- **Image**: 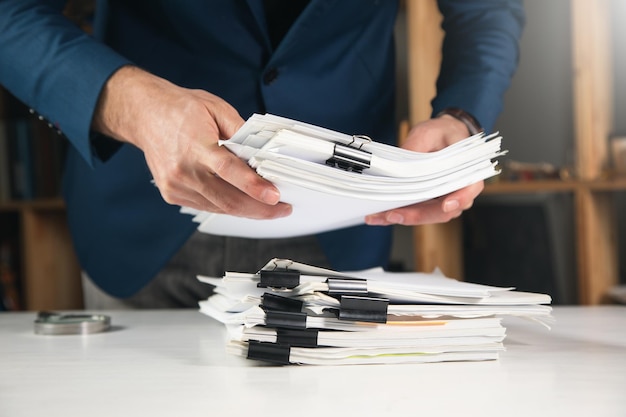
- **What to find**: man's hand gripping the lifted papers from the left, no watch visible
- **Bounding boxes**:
[92,66,291,219]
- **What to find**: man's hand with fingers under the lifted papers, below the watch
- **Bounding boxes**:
[365,115,484,226]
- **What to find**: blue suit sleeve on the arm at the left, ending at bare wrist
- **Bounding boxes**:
[0,0,129,165]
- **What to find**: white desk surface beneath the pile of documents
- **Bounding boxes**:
[0,306,626,417]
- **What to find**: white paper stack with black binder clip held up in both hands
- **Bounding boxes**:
[181,114,503,238]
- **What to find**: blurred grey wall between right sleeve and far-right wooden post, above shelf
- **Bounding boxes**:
[496,0,573,166]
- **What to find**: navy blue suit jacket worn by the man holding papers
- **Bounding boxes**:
[0,0,524,297]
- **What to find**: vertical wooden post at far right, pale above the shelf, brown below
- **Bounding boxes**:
[571,0,618,304]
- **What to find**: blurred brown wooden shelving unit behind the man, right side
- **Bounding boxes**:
[406,0,626,304]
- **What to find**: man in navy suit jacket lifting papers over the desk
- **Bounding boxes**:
[0,0,524,307]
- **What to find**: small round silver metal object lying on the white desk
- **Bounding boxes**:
[35,311,111,335]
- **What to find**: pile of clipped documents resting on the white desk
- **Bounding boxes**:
[198,259,552,365]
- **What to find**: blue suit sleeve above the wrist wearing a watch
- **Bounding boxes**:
[432,0,525,132]
